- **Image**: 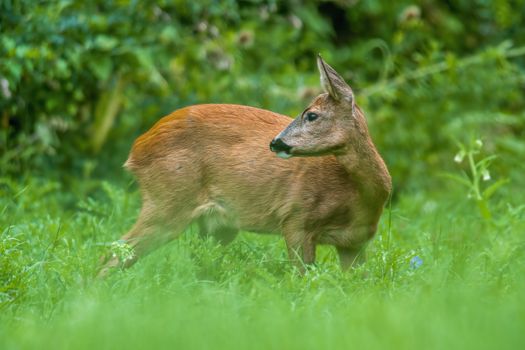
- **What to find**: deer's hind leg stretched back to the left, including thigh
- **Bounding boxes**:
[97,149,205,275]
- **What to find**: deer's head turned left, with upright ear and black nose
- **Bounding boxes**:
[270,56,368,158]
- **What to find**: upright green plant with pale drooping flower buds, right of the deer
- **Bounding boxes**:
[445,139,509,220]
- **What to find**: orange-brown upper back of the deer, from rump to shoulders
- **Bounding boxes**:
[126,104,291,170]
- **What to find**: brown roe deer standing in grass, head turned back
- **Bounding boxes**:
[99,55,392,276]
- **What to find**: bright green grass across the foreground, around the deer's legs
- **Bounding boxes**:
[0,179,525,349]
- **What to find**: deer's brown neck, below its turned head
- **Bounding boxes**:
[336,137,392,210]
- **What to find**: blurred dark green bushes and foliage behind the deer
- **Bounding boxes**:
[0,0,525,192]
